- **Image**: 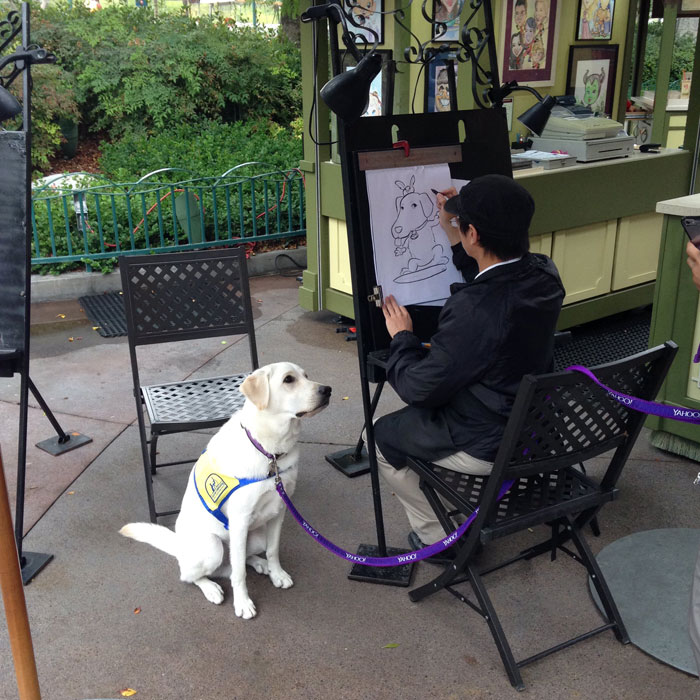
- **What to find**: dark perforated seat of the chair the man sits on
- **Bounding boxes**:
[422,459,617,542]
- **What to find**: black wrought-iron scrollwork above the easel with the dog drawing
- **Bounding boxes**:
[344,0,499,108]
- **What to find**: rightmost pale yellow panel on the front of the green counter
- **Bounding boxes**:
[612,212,664,291]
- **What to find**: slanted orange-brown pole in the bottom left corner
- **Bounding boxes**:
[0,454,41,700]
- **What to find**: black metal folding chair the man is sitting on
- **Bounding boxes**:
[409,341,678,690]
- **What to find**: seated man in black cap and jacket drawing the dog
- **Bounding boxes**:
[375,175,564,549]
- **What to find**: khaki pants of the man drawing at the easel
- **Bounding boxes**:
[377,448,493,544]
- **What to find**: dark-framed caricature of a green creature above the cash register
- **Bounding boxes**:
[566,44,619,115]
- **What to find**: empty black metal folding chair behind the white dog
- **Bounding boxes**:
[119,248,258,522]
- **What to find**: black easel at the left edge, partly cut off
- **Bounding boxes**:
[0,3,92,584]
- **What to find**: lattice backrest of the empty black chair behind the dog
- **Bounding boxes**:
[119,247,258,358]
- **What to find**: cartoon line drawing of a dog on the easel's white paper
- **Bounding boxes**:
[391,175,449,274]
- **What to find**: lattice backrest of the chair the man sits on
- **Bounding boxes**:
[483,341,678,520]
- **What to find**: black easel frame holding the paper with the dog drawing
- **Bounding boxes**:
[339,110,512,586]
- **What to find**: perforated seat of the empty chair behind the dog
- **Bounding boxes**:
[141,372,250,432]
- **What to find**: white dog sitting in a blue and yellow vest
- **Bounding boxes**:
[120,362,331,619]
